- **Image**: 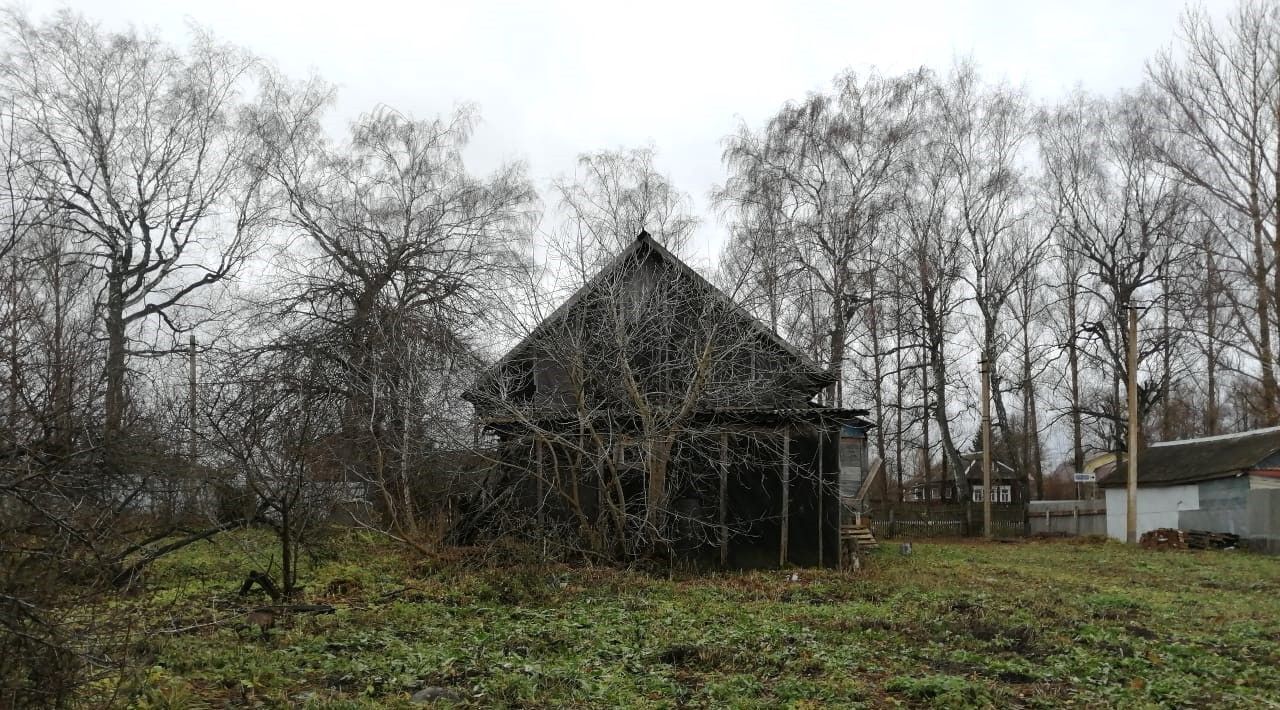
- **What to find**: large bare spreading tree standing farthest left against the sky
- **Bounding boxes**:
[0,12,270,438]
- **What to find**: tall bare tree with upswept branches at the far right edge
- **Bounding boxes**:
[1148,0,1280,425]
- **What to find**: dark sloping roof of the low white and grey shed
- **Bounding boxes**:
[1098,426,1280,486]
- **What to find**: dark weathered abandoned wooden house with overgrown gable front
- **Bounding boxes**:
[465,232,872,568]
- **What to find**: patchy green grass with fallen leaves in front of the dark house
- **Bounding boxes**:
[112,532,1280,709]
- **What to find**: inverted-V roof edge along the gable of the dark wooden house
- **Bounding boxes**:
[463,230,836,398]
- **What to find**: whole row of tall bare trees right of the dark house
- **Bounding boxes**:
[716,1,1280,495]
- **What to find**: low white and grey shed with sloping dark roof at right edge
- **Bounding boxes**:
[1098,427,1280,553]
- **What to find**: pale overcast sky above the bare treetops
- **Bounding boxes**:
[24,0,1234,264]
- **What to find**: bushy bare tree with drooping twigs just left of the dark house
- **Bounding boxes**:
[252,101,534,545]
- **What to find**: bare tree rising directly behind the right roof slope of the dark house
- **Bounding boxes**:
[718,72,924,403]
